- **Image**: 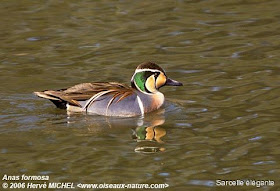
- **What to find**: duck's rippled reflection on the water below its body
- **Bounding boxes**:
[67,109,166,153]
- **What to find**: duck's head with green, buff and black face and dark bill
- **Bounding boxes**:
[131,62,183,94]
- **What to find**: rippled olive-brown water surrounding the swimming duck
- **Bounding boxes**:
[0,0,280,191]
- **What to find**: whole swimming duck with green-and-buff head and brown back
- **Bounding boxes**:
[34,62,183,117]
